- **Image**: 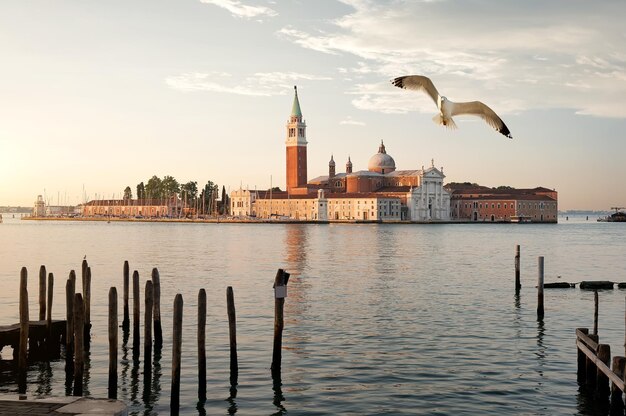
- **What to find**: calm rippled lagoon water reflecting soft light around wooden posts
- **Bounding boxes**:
[0,215,626,415]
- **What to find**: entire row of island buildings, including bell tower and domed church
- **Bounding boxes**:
[44,87,558,222]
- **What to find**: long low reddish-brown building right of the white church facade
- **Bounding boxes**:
[448,184,558,223]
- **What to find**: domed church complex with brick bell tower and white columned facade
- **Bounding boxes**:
[231,87,451,221]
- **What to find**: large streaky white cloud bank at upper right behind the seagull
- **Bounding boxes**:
[278,0,626,117]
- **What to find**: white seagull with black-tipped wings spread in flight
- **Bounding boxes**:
[391,75,513,139]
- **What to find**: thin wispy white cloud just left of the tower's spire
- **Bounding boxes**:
[165,72,332,97]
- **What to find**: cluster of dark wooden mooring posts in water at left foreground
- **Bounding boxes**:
[11,260,289,414]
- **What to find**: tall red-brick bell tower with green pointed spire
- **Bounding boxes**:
[285,86,307,193]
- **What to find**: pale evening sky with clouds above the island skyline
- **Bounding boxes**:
[0,0,626,210]
